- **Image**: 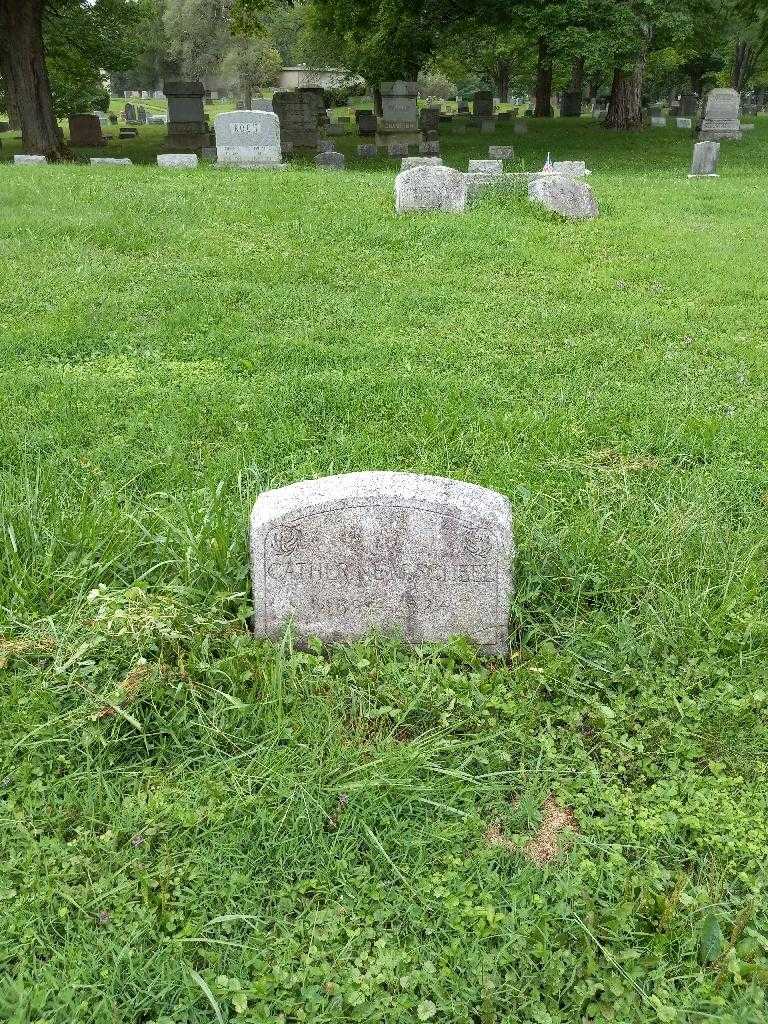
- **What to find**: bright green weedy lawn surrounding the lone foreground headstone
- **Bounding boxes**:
[0,124,768,1024]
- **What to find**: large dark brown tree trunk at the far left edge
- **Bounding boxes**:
[0,0,63,160]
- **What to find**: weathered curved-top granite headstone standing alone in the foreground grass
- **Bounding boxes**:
[251,472,514,654]
